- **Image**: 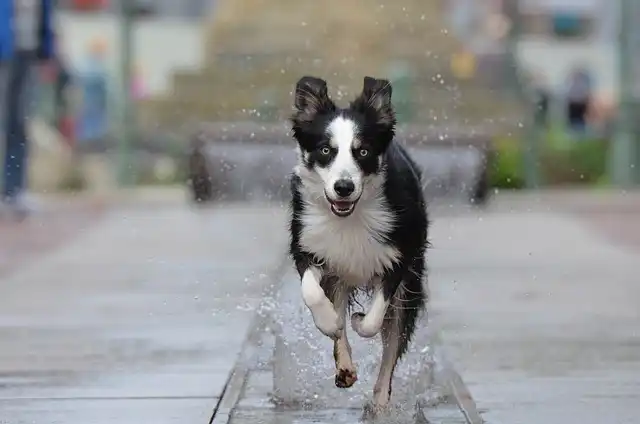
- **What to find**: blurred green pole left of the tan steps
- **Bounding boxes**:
[117,0,135,186]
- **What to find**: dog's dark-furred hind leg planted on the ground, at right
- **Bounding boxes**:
[373,278,425,413]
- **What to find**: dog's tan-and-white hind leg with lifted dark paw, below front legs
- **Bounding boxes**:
[330,283,358,388]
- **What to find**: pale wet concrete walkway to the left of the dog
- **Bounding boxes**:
[0,201,286,424]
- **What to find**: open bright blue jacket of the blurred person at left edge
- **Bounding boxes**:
[0,0,54,62]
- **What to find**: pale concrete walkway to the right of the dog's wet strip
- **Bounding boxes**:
[430,199,640,424]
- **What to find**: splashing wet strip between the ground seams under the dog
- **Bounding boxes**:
[222,264,480,424]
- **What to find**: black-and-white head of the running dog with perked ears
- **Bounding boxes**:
[291,76,396,217]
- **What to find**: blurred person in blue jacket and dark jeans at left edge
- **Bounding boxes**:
[0,0,54,217]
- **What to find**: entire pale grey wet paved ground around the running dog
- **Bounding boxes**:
[0,192,640,424]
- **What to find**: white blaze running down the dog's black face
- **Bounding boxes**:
[318,116,362,199]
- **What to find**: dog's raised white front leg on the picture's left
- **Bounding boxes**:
[302,266,344,340]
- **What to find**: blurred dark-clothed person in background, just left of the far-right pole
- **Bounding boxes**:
[566,67,593,134]
